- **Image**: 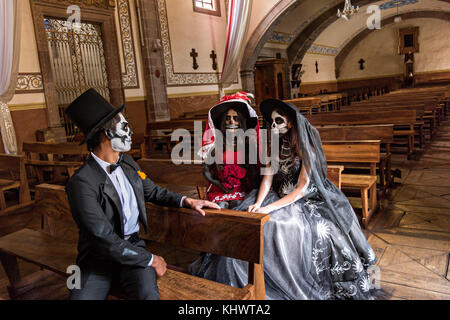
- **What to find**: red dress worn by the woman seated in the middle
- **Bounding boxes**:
[206,151,250,203]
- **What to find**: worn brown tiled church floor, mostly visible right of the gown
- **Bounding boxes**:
[0,121,450,299]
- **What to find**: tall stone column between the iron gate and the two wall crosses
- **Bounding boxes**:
[136,0,170,121]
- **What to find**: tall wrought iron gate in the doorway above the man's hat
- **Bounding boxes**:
[44,18,109,139]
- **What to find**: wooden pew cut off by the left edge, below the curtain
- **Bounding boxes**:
[0,154,33,215]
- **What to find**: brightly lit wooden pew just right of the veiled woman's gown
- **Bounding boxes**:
[323,140,381,228]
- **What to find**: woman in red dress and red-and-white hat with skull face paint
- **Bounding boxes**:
[199,92,259,209]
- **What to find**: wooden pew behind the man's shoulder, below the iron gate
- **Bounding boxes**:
[22,141,89,183]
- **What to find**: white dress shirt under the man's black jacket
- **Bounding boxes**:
[91,152,153,266]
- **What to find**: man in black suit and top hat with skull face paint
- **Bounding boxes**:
[66,89,219,300]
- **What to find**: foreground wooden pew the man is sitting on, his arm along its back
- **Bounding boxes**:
[0,184,269,300]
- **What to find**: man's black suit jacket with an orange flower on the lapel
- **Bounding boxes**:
[66,154,182,268]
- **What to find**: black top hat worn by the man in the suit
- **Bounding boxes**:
[65,89,125,144]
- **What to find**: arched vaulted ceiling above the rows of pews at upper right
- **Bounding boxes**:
[265,0,450,63]
